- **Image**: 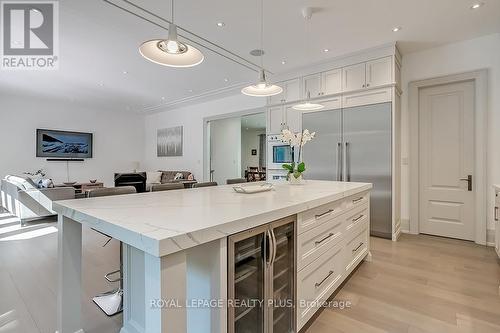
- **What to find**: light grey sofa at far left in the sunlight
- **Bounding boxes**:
[1,175,75,225]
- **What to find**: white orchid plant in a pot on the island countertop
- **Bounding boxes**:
[281,129,316,181]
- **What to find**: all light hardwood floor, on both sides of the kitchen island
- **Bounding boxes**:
[0,209,500,333]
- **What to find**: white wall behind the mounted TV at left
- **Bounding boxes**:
[0,95,144,186]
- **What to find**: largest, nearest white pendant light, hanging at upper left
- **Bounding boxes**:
[139,0,205,67]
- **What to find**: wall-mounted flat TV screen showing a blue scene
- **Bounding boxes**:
[36,129,92,158]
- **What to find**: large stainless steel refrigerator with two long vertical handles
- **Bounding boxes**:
[302,103,392,238]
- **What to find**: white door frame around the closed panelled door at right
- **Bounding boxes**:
[408,69,488,245]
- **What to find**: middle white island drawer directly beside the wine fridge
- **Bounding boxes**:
[297,216,344,270]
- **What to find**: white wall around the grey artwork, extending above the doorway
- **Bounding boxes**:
[144,94,266,180]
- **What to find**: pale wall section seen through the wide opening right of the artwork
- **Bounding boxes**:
[210,117,241,184]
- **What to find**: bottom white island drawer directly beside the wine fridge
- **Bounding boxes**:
[297,243,344,330]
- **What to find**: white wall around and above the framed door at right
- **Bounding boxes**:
[401,34,500,229]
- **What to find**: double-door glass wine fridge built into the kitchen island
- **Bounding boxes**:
[228,217,296,333]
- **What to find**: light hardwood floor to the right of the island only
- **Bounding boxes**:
[307,235,500,333]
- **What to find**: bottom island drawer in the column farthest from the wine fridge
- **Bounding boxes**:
[344,220,368,274]
